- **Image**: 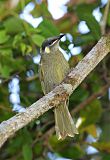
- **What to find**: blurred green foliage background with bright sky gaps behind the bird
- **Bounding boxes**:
[0,0,110,160]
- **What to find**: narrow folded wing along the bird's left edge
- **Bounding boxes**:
[39,62,46,94]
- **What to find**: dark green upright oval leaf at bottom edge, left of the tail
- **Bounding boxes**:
[22,144,33,160]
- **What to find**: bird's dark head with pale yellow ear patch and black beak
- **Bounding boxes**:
[41,34,65,53]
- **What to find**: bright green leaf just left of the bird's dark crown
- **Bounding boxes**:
[32,34,45,47]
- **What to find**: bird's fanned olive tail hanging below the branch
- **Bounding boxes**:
[54,103,78,139]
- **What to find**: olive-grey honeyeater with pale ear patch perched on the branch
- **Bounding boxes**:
[39,34,78,139]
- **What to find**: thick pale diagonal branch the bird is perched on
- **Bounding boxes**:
[0,37,110,147]
